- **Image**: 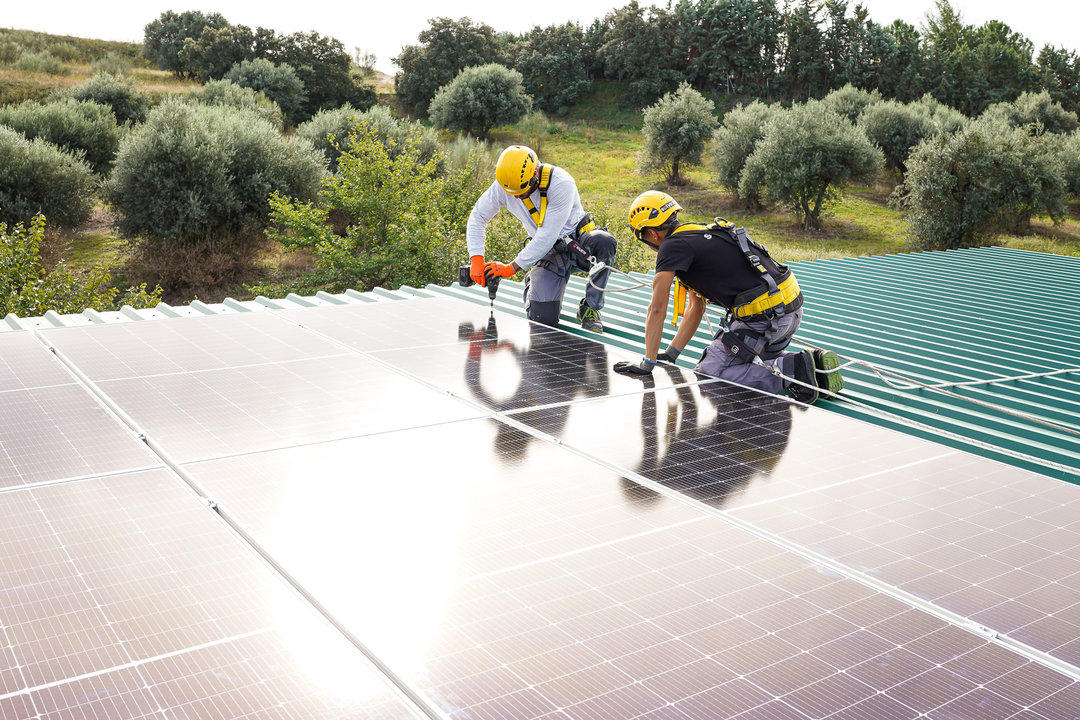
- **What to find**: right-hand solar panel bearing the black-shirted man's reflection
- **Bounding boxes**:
[514,375,1080,665]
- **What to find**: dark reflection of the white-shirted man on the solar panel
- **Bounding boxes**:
[458,315,610,463]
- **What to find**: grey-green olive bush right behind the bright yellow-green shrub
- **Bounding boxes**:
[296,105,443,173]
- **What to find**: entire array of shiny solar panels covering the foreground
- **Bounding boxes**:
[0,300,1080,720]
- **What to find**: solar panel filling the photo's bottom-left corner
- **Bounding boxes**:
[0,470,422,720]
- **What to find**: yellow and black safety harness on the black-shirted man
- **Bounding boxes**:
[672,218,802,363]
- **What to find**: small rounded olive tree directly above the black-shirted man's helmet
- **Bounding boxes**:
[642,82,717,185]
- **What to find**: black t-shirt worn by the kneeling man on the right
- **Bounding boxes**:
[657,222,775,310]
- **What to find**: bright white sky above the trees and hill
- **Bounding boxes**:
[8,0,1080,74]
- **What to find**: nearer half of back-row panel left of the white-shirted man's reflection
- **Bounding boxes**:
[92,354,477,461]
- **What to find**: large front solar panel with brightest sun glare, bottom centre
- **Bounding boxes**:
[185,416,1071,719]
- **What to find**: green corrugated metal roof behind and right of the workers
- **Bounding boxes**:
[429,247,1080,483]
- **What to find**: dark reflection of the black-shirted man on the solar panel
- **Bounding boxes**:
[622,366,794,507]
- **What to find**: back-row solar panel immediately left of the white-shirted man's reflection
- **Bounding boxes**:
[46,314,477,461]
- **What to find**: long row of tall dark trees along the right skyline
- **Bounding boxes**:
[394,0,1080,117]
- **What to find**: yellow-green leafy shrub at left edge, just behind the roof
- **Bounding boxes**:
[0,215,161,316]
